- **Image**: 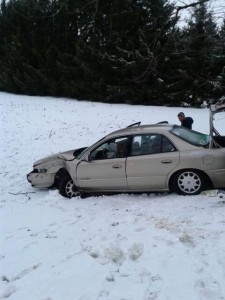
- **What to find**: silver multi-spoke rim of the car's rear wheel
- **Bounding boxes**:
[178,172,202,194]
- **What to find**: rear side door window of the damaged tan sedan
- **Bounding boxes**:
[130,134,176,156]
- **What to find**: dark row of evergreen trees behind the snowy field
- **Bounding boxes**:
[0,0,225,107]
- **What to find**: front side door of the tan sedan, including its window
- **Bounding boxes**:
[76,137,128,191]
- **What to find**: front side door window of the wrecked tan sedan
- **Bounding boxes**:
[90,137,128,160]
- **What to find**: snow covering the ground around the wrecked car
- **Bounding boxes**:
[0,93,225,300]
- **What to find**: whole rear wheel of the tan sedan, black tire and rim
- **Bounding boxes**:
[171,170,205,196]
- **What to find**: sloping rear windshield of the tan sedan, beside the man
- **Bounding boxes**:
[170,125,209,147]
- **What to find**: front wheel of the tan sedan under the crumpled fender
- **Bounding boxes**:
[59,174,80,198]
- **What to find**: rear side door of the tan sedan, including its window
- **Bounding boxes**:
[126,134,179,191]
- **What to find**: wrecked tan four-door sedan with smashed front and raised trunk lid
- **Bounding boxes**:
[27,105,225,198]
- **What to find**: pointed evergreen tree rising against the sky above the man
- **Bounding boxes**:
[181,4,219,106]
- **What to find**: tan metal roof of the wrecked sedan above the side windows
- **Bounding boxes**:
[107,124,174,137]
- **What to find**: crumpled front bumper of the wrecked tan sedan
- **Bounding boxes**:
[27,170,55,188]
